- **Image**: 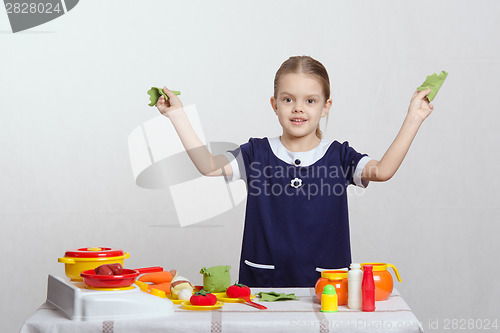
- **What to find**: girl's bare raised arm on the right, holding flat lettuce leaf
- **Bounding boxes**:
[361,89,434,182]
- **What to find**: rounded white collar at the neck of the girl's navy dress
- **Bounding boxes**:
[267,136,332,166]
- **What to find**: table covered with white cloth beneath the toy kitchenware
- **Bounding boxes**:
[20,288,423,333]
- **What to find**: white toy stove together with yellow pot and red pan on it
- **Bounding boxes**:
[47,247,174,321]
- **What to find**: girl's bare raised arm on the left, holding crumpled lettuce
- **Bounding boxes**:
[156,87,233,176]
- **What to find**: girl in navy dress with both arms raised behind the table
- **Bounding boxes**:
[157,56,433,287]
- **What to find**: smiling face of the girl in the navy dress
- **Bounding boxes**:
[271,73,332,139]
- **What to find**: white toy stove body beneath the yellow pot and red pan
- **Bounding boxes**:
[47,274,174,321]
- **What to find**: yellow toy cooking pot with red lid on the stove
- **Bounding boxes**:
[58,247,130,281]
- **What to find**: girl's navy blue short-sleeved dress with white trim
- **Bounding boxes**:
[227,138,366,287]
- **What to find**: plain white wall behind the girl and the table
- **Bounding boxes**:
[0,0,500,332]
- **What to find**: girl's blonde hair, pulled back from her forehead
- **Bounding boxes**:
[274,56,330,139]
